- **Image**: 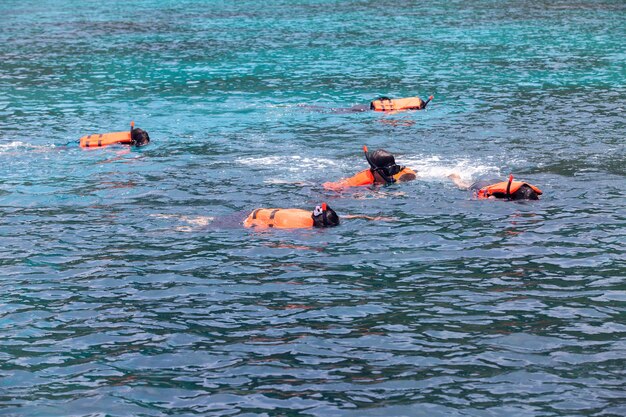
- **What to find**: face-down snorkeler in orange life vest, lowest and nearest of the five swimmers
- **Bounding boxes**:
[243,203,339,229]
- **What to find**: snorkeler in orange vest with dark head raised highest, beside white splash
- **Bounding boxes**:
[322,146,417,191]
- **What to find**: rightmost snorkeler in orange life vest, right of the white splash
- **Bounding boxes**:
[448,174,543,200]
